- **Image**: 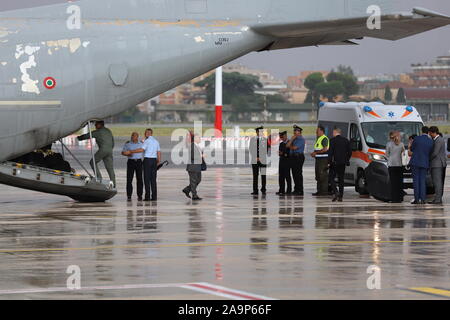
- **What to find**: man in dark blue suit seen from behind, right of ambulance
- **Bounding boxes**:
[409,127,433,204]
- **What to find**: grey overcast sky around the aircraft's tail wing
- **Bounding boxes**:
[238,0,450,79]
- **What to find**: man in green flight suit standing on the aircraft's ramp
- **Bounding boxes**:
[78,121,116,187]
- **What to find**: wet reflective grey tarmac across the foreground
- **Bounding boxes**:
[0,166,450,300]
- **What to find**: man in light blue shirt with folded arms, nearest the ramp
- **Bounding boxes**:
[122,132,144,201]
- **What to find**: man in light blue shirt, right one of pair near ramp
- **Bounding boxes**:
[127,129,161,201]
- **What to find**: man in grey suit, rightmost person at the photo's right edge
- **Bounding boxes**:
[429,127,447,204]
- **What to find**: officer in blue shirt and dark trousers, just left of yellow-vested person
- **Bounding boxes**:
[286,125,306,196]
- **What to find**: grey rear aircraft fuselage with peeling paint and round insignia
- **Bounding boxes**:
[0,0,271,161]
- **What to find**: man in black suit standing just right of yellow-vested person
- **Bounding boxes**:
[328,128,352,202]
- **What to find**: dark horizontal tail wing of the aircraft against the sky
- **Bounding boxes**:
[253,8,450,50]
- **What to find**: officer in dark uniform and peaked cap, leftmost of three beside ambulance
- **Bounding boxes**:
[250,126,269,195]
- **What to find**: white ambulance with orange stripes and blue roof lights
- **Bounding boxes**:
[319,102,423,194]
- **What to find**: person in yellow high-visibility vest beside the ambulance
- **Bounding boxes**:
[311,126,330,196]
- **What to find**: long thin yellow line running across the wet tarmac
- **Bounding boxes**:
[0,240,450,253]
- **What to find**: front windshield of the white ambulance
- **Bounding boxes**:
[362,122,423,149]
